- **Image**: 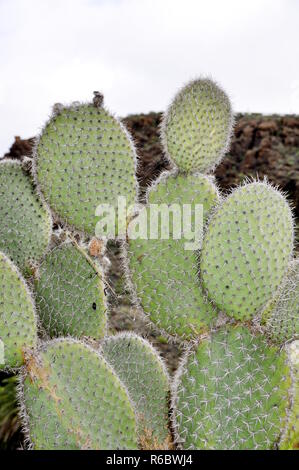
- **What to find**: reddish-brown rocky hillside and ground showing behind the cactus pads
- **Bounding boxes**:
[0,113,299,449]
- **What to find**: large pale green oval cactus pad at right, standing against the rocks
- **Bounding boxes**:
[200,182,293,320]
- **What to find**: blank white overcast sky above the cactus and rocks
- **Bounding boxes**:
[0,0,299,156]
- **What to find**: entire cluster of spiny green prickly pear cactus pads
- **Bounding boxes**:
[0,79,299,450]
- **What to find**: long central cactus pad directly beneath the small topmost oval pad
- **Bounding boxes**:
[128,174,218,338]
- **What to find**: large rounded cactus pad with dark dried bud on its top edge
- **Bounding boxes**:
[35,104,136,236]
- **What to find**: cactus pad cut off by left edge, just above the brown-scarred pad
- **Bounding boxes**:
[0,252,37,369]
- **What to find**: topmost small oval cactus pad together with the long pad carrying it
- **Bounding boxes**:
[127,80,233,339]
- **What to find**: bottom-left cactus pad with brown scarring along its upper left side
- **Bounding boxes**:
[21,339,137,450]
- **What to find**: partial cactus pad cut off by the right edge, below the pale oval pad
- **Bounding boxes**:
[266,259,299,343]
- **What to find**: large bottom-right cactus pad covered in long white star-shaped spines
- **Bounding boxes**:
[173,326,291,450]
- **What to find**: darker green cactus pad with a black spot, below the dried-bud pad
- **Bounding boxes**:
[35,242,107,339]
